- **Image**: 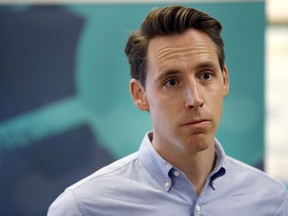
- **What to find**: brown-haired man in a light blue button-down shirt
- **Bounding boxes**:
[48,6,288,216]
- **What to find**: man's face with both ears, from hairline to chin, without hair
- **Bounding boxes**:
[131,29,229,155]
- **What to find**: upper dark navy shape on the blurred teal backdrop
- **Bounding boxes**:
[0,6,85,121]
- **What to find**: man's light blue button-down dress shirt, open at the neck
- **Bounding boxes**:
[48,133,288,216]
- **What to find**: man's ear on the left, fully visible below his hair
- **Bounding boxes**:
[130,79,149,111]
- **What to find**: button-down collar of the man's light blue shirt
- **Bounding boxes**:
[139,131,226,191]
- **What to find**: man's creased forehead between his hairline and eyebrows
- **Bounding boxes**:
[147,29,218,69]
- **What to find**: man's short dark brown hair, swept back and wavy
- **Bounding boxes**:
[125,6,225,88]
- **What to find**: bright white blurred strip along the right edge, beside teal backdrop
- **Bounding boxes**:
[264,0,288,189]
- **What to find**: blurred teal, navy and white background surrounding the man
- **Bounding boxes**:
[0,0,288,216]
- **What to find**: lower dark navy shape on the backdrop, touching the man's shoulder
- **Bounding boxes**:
[0,125,114,216]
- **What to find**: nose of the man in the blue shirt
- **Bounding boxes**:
[185,83,204,109]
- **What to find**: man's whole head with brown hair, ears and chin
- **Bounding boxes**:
[126,4,229,157]
